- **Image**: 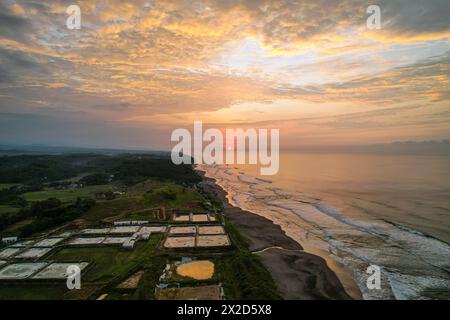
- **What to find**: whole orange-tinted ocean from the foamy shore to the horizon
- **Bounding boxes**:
[198,152,450,299]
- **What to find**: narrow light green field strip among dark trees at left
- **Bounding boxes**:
[23,184,114,202]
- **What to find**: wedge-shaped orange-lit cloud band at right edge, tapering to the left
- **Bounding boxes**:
[274,52,450,104]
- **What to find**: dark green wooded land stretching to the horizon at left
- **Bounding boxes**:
[0,154,201,236]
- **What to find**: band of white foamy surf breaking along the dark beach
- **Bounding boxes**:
[198,165,450,299]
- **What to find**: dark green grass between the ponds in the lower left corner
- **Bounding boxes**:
[0,234,165,300]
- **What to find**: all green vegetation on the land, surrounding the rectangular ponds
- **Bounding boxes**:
[0,154,280,299]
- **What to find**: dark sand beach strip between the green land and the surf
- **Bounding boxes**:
[197,170,361,300]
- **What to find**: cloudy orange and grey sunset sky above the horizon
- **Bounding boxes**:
[0,0,450,149]
